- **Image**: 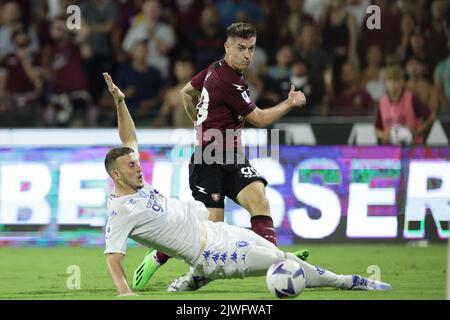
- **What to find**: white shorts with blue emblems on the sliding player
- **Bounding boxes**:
[193,221,279,279]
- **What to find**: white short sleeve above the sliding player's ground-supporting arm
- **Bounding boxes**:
[104,216,131,255]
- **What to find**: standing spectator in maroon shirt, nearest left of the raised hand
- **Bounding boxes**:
[42,18,96,127]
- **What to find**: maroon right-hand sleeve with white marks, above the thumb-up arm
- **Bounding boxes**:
[221,83,256,117]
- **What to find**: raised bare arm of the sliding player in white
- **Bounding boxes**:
[103,72,139,152]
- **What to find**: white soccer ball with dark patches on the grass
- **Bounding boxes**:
[266,260,306,299]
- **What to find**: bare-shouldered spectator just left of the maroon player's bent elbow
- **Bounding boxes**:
[153,58,195,128]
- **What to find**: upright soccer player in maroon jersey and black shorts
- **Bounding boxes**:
[133,22,308,289]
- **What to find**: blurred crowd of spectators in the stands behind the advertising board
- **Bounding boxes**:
[0,0,450,128]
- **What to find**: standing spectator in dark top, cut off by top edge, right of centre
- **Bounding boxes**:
[321,0,359,91]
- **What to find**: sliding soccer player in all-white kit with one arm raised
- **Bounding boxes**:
[103,73,391,296]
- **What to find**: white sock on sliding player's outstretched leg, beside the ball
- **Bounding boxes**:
[286,252,353,289]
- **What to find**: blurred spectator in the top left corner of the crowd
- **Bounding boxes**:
[0,0,39,60]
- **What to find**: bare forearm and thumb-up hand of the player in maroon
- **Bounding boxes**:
[245,85,306,128]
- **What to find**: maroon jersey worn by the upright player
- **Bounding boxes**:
[191,60,256,149]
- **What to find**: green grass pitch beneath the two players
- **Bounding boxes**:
[0,244,448,300]
